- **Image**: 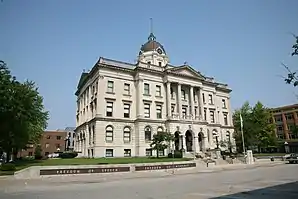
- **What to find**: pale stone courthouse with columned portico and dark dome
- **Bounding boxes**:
[75,33,234,157]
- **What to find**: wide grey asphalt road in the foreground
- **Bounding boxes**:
[0,164,298,199]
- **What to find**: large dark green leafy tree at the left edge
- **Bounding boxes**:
[0,61,48,160]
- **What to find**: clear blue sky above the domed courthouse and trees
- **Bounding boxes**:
[0,0,298,129]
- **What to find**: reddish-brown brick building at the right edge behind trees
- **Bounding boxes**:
[271,104,298,152]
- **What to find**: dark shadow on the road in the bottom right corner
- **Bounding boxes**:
[211,181,298,199]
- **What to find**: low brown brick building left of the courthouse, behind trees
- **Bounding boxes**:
[19,130,67,157]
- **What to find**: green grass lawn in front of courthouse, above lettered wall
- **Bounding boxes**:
[0,157,191,176]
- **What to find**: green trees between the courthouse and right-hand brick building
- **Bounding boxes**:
[233,102,277,151]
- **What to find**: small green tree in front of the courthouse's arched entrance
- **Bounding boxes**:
[150,132,175,158]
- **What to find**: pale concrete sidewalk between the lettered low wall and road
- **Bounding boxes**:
[0,161,285,188]
